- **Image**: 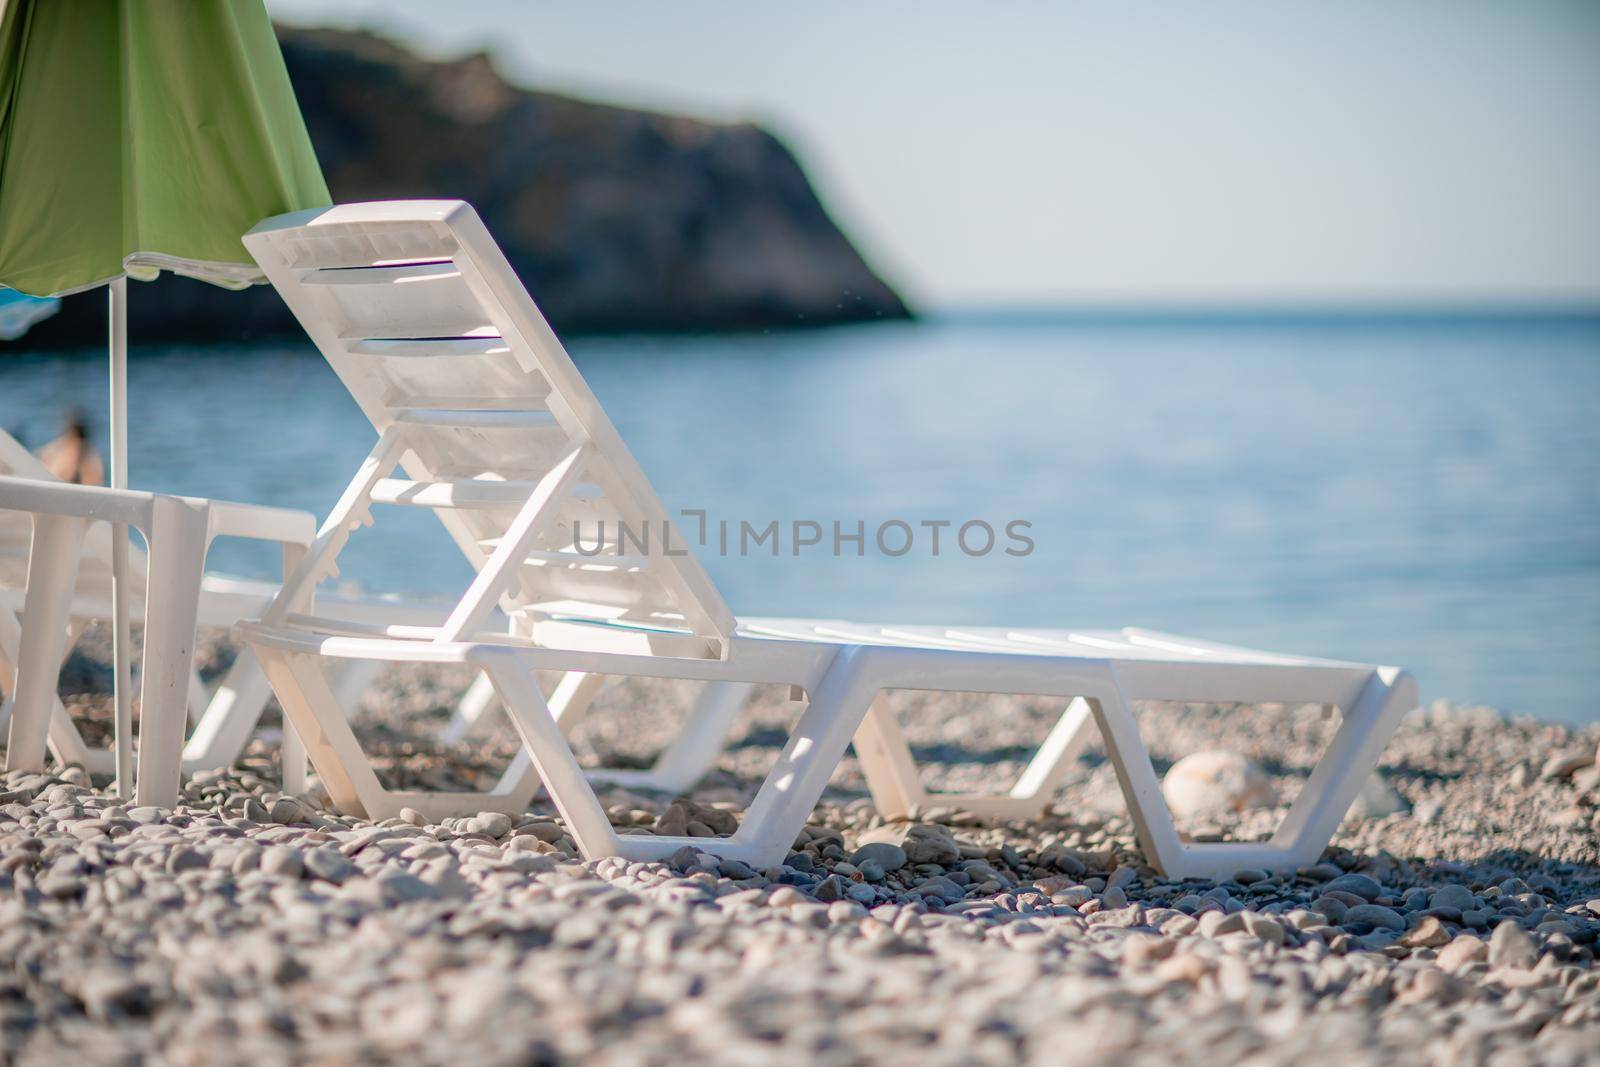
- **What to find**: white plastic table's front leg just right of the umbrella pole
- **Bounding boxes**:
[134,496,206,808]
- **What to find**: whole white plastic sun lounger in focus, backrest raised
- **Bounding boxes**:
[240,200,1416,877]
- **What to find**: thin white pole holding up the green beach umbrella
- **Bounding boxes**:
[106,278,133,800]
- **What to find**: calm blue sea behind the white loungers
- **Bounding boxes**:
[0,318,1600,720]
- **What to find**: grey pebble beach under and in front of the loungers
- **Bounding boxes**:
[0,645,1600,1067]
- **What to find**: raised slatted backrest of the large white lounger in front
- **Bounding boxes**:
[245,200,734,656]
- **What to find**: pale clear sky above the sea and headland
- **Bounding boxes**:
[267,0,1600,309]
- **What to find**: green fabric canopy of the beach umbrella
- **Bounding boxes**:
[0,0,330,296]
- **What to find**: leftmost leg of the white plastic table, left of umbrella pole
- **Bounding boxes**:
[6,515,86,771]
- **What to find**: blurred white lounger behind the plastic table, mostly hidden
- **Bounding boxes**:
[0,430,448,787]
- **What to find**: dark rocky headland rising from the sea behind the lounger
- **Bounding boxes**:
[8,27,907,347]
